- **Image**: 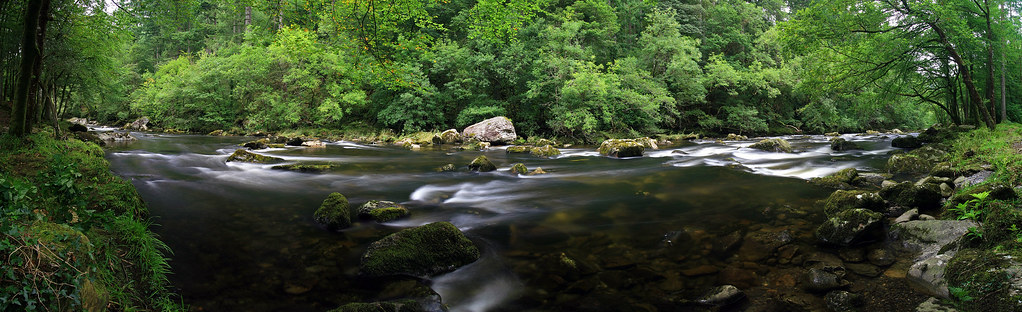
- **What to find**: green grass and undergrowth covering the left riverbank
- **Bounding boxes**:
[0,129,184,311]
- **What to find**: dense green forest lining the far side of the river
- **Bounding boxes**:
[0,0,1022,141]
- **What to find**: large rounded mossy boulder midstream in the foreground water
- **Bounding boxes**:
[360,222,479,277]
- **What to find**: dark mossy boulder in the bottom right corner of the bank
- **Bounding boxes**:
[945,246,1022,311]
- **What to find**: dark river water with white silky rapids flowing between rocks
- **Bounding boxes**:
[107,134,919,311]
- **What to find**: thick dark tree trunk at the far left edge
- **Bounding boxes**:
[8,0,43,137]
